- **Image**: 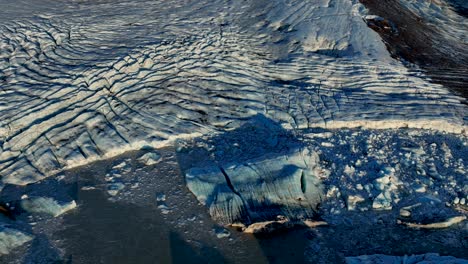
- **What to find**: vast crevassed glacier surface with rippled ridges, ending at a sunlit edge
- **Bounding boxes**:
[0,0,466,184]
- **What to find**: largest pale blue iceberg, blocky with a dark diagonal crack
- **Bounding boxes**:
[186,151,323,223]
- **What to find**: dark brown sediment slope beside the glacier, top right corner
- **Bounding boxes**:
[360,0,468,100]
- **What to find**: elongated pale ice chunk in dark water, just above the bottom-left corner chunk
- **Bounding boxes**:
[21,197,76,217]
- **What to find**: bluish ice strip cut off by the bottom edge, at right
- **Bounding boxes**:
[346,253,468,264]
